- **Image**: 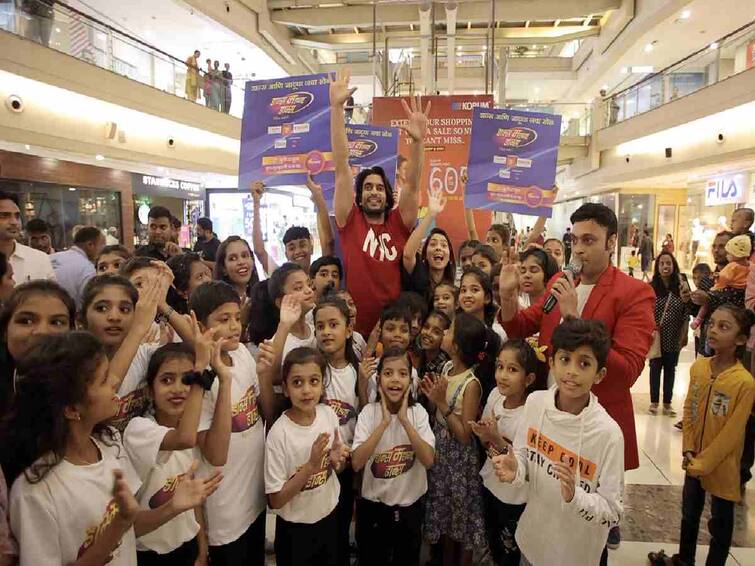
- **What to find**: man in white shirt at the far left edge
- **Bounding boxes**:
[0,191,55,285]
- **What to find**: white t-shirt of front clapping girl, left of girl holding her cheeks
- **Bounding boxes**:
[265,404,341,524]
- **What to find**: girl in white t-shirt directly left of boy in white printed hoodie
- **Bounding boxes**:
[472,340,548,566]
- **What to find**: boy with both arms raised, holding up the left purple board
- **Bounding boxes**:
[251,175,335,275]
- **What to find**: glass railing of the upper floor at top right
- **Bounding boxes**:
[597,21,755,129]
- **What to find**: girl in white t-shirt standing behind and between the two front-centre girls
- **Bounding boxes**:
[314,294,360,564]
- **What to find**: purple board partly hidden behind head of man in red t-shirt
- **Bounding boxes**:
[315,124,399,210]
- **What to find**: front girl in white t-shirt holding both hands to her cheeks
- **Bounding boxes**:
[352,348,435,566]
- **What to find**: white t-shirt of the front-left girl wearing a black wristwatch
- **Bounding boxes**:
[123,416,199,554]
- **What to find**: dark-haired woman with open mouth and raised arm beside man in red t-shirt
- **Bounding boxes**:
[401,190,456,299]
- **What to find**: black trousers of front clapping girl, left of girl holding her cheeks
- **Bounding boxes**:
[276,508,338,566]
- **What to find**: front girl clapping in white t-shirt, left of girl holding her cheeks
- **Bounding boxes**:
[265,348,348,566]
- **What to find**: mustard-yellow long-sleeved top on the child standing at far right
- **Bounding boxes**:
[682,358,755,501]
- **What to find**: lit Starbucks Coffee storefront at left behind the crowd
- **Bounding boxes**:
[131,173,205,247]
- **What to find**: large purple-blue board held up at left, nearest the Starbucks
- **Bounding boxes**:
[239,73,333,191]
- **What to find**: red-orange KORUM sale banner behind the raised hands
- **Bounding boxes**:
[372,94,493,250]
